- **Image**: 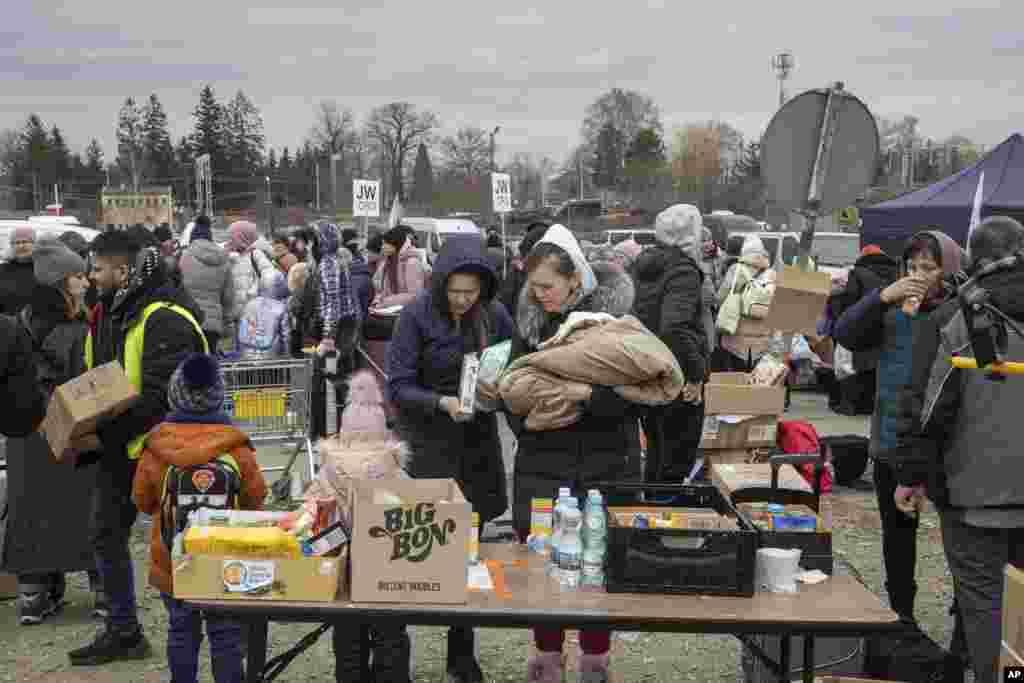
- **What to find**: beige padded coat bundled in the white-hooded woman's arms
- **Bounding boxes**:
[499,313,684,431]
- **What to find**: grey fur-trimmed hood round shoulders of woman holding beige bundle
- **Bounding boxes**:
[516,263,636,347]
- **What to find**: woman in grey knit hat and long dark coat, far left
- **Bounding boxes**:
[0,241,106,626]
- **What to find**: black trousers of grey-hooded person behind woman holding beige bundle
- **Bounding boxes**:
[641,399,705,483]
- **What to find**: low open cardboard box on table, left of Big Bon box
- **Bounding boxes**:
[172,548,348,602]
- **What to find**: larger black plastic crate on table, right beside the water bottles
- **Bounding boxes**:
[594,483,758,597]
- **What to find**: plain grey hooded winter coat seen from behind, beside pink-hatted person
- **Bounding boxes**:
[178,240,238,335]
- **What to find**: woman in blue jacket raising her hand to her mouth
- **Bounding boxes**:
[833,230,963,623]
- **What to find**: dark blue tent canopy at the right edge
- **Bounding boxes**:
[860,133,1024,254]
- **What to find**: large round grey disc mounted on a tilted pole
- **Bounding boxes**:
[761,83,879,215]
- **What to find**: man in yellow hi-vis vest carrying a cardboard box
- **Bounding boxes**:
[69,232,209,666]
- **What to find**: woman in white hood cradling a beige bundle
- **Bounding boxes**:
[509,225,640,683]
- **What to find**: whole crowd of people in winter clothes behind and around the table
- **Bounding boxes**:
[0,205,1024,683]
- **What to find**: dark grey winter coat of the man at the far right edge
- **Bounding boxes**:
[892,265,1024,528]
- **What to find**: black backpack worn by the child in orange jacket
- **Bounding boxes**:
[160,454,242,549]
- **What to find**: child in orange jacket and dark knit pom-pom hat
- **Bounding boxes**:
[132,353,266,683]
